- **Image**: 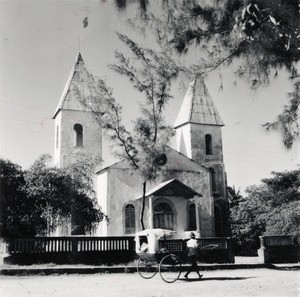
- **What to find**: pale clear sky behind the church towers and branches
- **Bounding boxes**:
[0,0,300,192]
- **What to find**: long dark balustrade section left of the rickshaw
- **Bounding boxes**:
[5,236,134,264]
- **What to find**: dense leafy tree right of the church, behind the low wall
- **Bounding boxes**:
[231,170,300,250]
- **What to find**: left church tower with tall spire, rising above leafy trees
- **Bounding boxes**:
[53,52,102,167]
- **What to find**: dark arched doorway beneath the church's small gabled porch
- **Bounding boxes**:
[154,202,174,230]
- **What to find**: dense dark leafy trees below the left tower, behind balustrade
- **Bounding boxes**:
[0,155,105,237]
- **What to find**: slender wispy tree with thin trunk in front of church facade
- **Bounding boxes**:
[74,34,177,229]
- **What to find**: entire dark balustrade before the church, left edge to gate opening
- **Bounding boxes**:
[4,236,234,265]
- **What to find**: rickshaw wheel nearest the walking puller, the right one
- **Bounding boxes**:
[159,254,181,283]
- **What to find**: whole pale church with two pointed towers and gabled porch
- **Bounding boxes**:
[53,53,230,238]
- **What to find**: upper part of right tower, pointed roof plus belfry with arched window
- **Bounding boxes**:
[174,76,224,165]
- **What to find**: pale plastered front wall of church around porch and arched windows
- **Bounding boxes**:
[98,157,214,237]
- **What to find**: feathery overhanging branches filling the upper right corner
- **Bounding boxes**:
[115,0,300,148]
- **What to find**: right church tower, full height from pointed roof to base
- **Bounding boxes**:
[174,76,230,236]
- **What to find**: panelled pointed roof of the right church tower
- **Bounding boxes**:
[174,76,224,128]
